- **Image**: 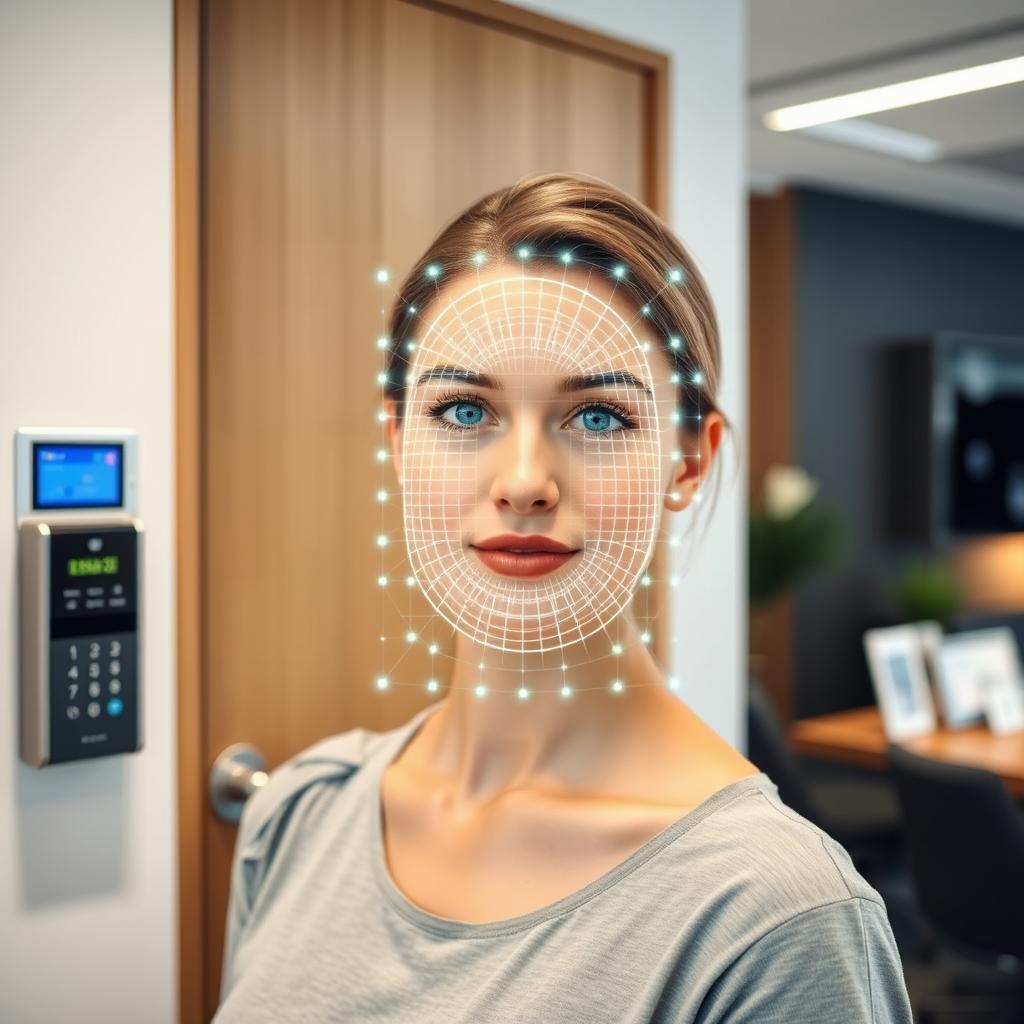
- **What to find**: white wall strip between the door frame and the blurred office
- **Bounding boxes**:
[515,0,746,752]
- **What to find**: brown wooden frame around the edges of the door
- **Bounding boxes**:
[174,0,670,1024]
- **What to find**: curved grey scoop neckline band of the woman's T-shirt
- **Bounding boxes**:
[368,701,774,939]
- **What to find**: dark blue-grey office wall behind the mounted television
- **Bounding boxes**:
[794,189,1024,717]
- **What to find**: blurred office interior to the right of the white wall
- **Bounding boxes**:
[746,0,1024,1021]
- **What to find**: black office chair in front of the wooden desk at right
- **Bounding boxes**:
[889,744,1024,1022]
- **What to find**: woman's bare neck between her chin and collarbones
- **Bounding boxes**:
[403,613,687,807]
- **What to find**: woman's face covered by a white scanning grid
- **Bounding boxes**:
[392,264,682,652]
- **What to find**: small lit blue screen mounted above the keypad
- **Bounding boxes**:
[32,441,124,509]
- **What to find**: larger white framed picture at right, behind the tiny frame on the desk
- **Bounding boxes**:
[938,626,1022,731]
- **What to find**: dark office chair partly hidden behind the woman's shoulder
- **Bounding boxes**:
[746,679,900,876]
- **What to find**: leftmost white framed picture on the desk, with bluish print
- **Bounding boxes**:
[864,626,936,742]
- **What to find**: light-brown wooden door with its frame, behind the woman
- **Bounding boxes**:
[176,0,667,1021]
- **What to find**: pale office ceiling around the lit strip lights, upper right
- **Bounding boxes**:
[748,0,1024,224]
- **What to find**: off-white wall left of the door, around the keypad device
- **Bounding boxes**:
[0,0,177,1024]
